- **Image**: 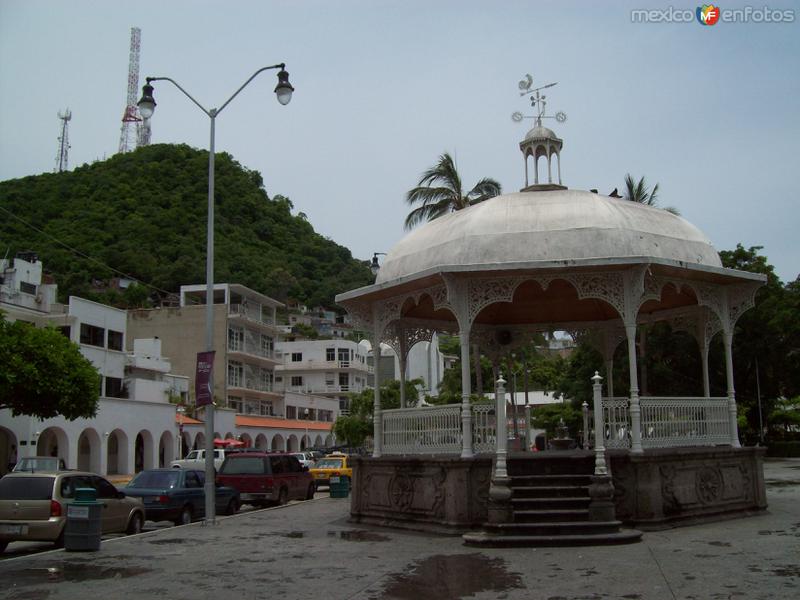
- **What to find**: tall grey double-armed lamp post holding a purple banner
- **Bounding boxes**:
[138,63,294,525]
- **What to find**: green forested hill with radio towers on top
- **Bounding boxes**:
[0,144,373,307]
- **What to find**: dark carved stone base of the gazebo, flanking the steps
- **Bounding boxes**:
[350,447,767,535]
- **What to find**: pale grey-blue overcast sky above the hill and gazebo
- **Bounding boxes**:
[0,0,800,282]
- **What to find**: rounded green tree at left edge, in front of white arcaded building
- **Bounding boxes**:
[0,315,100,421]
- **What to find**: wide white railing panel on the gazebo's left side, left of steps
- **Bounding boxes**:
[381,404,461,454]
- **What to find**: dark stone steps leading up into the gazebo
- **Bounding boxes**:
[463,452,642,547]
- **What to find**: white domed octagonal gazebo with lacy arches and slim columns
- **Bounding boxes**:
[336,123,765,540]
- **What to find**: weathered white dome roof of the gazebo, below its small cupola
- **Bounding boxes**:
[376,189,722,284]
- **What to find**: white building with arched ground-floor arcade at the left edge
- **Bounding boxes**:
[0,253,188,474]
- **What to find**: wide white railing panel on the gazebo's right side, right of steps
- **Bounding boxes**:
[639,397,731,448]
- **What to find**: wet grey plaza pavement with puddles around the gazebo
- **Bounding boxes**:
[0,459,800,600]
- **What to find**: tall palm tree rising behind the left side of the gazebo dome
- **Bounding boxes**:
[405,152,501,229]
